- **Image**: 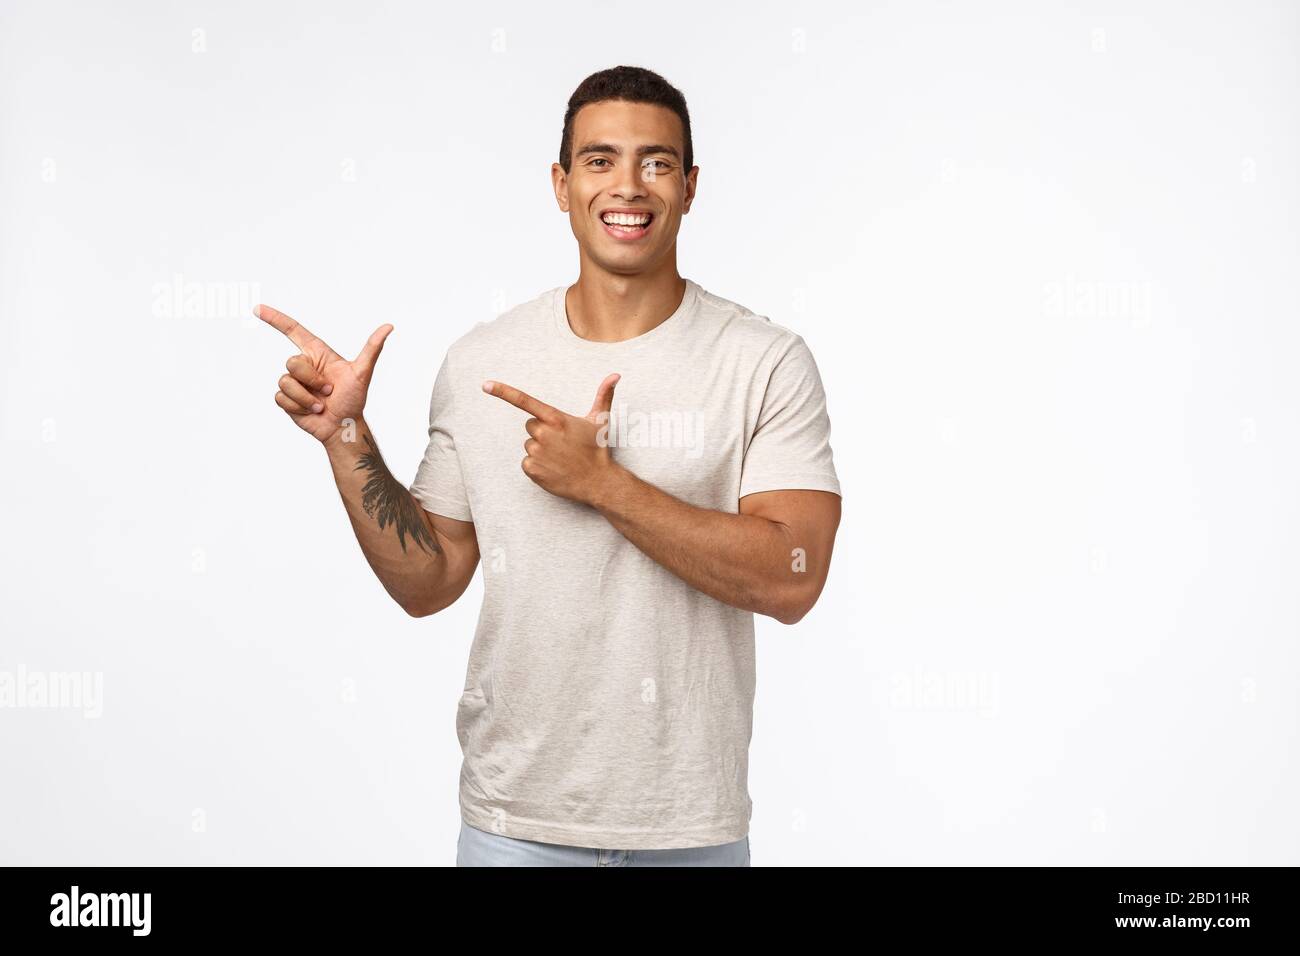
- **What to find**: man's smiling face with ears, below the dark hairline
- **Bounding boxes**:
[551,100,699,276]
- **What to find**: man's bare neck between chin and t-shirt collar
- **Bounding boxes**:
[564,263,686,342]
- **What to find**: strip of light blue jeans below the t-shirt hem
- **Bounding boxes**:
[456,821,749,866]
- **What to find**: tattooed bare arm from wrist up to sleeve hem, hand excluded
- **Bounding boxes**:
[324,420,478,618]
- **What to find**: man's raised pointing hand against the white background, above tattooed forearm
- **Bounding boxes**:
[254,306,393,442]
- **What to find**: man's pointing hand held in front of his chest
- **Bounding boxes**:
[484,373,619,505]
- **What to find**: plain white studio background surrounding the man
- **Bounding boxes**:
[0,0,1300,865]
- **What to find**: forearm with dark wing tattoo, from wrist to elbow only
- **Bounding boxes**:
[325,419,447,613]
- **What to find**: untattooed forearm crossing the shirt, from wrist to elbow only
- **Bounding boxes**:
[592,466,809,623]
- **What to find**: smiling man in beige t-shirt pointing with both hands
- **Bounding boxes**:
[259,66,840,866]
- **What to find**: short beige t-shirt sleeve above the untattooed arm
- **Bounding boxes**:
[740,336,840,498]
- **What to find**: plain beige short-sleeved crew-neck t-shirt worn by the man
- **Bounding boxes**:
[411,280,840,849]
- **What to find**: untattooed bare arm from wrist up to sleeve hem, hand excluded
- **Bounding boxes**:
[590,466,840,624]
